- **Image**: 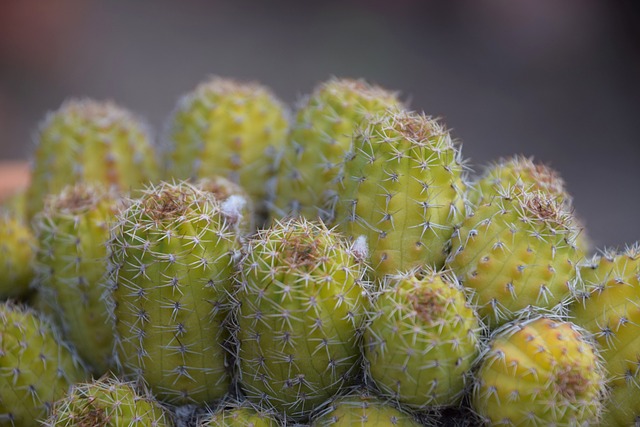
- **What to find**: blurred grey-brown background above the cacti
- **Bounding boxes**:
[0,0,640,247]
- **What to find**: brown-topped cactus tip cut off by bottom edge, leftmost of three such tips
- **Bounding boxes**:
[43,377,171,427]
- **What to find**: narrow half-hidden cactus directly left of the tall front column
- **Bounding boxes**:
[34,184,119,376]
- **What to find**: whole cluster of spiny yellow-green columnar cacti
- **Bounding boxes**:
[0,77,640,427]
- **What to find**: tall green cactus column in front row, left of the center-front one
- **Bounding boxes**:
[109,183,240,404]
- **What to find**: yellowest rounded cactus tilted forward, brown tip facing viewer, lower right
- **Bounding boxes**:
[472,317,604,427]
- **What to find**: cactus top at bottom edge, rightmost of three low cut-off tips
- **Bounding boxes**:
[311,394,421,427]
